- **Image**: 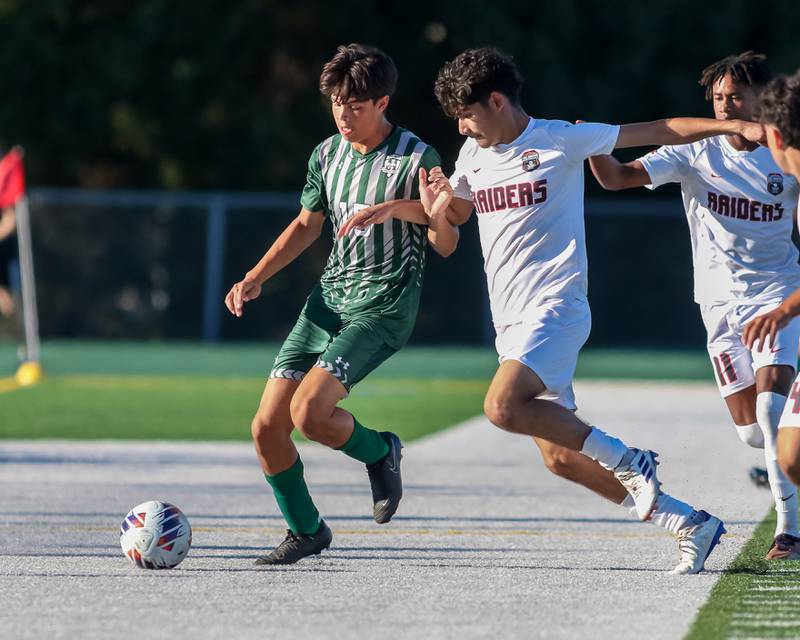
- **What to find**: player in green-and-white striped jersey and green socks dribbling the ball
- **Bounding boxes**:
[225,44,458,564]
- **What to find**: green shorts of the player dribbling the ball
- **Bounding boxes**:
[269,304,397,393]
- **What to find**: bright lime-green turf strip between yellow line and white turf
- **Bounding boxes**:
[0,374,487,440]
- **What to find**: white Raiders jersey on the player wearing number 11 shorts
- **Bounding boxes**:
[639,136,800,305]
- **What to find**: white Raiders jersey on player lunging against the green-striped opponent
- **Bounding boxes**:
[450,118,619,327]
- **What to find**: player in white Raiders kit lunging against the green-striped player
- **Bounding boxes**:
[352,48,763,573]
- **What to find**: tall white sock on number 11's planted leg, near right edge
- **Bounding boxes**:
[756,391,800,536]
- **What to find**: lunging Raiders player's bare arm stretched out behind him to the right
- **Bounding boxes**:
[615,118,766,149]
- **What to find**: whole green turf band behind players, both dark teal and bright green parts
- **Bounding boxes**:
[0,342,711,440]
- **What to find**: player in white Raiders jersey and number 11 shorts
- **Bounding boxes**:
[589,51,800,559]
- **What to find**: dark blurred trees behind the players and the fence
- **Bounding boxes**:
[0,0,800,346]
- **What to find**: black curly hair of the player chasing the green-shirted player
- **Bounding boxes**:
[434,47,522,118]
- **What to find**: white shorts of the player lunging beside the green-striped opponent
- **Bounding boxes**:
[495,299,592,411]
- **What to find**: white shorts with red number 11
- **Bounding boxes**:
[700,302,800,398]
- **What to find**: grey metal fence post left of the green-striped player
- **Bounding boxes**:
[203,196,227,342]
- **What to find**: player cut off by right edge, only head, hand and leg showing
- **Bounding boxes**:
[744,70,800,524]
